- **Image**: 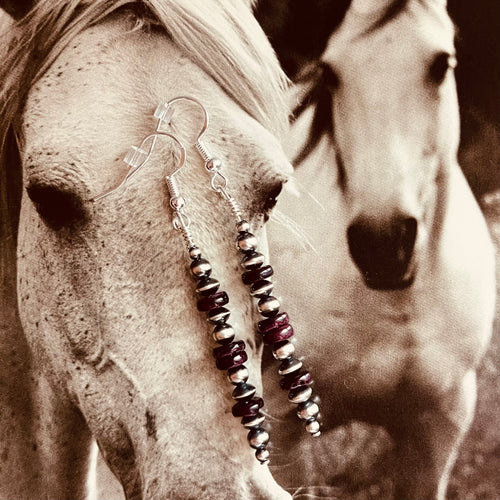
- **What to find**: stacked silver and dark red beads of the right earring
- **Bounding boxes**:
[236,220,321,437]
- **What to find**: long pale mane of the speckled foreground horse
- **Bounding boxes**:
[0,0,288,286]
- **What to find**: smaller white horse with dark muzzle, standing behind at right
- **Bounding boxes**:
[264,0,495,500]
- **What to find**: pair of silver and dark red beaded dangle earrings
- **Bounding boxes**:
[96,96,321,463]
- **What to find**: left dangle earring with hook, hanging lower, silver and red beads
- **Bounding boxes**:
[95,115,269,464]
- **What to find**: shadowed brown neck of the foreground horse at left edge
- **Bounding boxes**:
[0,143,95,498]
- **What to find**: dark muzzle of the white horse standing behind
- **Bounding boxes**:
[347,214,418,290]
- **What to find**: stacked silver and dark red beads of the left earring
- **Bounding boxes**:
[189,246,269,463]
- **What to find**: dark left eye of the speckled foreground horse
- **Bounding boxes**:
[26,184,85,229]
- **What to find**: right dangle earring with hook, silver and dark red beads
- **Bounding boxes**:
[155,97,321,437]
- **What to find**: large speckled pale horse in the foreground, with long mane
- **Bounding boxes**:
[0,0,289,500]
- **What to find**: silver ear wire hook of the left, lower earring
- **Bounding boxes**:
[94,131,186,201]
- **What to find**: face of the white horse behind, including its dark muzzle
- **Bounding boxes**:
[323,1,459,289]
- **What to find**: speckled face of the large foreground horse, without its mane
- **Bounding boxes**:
[18,11,288,498]
